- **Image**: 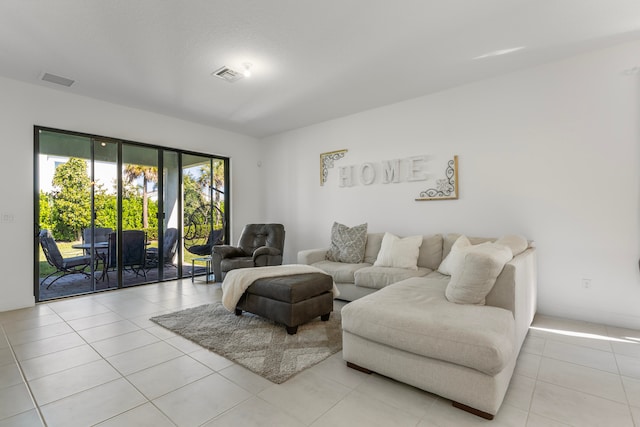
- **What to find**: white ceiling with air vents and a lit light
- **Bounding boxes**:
[0,0,640,138]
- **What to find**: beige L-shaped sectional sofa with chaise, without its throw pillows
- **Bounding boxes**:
[298,233,537,419]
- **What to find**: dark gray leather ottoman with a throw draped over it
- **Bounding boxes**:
[236,273,333,335]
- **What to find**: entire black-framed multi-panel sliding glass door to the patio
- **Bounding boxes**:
[34,127,228,301]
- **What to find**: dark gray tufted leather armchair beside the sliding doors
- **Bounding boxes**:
[211,224,284,282]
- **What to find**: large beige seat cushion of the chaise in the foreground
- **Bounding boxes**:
[342,276,515,375]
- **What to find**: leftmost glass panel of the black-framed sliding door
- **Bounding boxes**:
[37,131,102,299]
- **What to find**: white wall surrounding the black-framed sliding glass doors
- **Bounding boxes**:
[0,78,263,311]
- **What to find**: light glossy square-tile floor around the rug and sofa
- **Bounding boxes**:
[0,280,640,427]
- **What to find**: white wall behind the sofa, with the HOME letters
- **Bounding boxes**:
[263,42,640,328]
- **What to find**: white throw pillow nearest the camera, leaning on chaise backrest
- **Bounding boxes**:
[445,243,513,305]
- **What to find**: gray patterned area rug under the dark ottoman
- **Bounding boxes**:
[150,302,342,384]
